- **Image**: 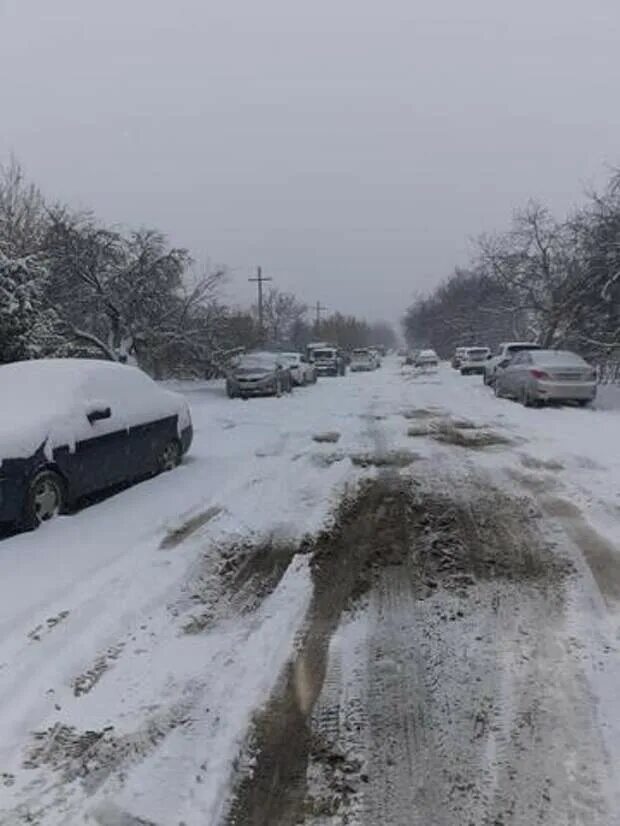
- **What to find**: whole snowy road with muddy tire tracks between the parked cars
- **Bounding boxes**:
[0,360,620,826]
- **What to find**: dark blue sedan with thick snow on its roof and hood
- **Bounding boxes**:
[0,359,192,528]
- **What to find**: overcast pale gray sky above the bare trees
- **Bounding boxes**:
[0,0,620,320]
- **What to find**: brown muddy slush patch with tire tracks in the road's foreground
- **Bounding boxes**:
[226,462,612,826]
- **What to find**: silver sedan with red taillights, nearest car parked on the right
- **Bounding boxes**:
[495,350,596,407]
